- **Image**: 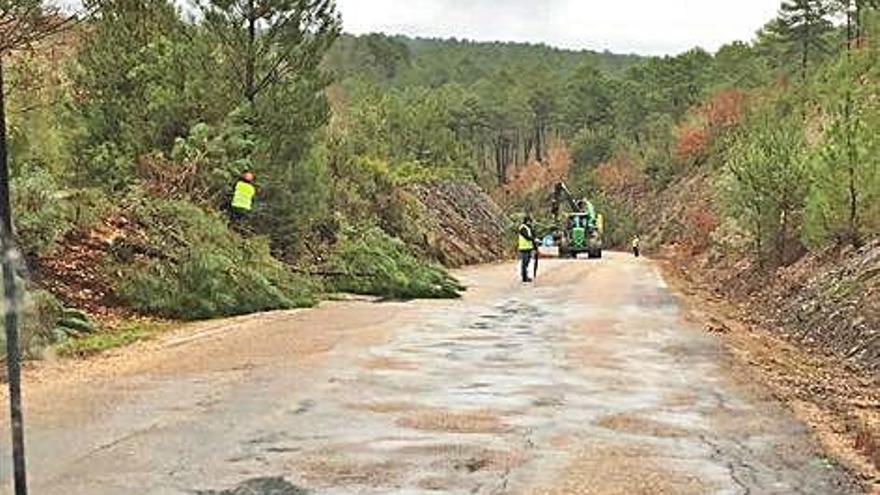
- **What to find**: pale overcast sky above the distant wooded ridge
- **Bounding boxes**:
[337,0,780,55]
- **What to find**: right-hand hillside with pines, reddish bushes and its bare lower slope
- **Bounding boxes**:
[556,1,880,378]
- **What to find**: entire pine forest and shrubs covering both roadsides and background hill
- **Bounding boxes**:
[0,0,880,356]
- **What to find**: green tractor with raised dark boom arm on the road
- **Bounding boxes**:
[552,182,605,259]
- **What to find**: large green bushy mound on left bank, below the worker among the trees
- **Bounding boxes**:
[119,200,316,320]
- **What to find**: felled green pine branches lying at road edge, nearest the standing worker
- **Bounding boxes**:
[331,227,464,299]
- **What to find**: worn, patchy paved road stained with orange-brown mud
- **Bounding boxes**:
[3,254,856,495]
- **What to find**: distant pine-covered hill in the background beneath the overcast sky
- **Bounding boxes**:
[327,35,644,188]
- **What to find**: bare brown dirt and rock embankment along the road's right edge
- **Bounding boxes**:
[639,174,880,487]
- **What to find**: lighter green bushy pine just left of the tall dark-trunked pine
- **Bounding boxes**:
[74,0,194,170]
